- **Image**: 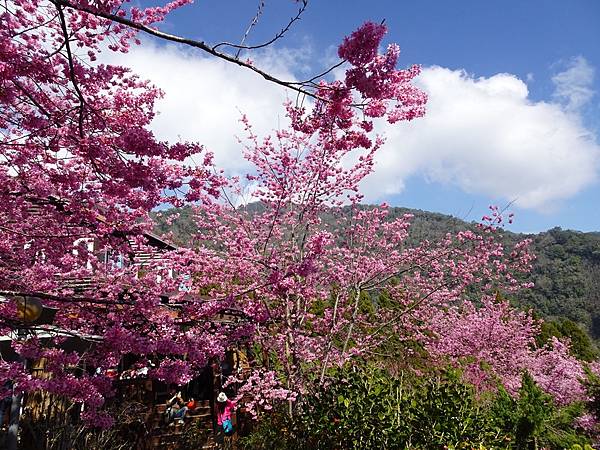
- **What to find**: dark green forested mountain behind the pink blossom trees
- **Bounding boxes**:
[155,205,600,342]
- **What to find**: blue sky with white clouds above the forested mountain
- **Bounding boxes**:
[127,0,600,231]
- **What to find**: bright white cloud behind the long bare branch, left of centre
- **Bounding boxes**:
[100,42,298,174]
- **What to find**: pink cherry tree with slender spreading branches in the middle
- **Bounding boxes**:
[177,43,532,412]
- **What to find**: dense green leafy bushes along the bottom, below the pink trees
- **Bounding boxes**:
[243,366,591,449]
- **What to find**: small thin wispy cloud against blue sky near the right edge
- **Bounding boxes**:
[552,56,594,111]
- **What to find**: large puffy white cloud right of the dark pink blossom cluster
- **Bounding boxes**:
[364,67,600,210]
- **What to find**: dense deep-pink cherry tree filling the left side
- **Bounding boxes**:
[0,1,244,425]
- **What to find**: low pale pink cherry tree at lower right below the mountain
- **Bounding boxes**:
[424,296,586,405]
